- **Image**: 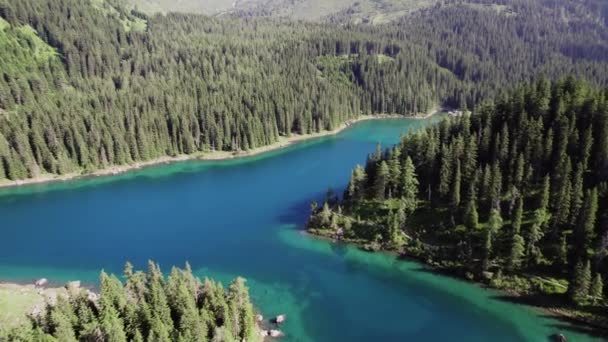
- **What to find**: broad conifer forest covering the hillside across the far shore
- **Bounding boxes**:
[0,0,608,181]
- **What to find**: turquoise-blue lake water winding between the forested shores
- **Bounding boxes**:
[0,119,591,341]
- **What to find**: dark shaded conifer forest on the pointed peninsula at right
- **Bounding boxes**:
[308,78,608,326]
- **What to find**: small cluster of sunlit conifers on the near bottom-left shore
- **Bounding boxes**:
[0,262,261,342]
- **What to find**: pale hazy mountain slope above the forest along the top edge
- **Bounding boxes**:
[125,0,608,25]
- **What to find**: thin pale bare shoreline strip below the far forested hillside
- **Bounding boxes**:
[0,107,445,189]
